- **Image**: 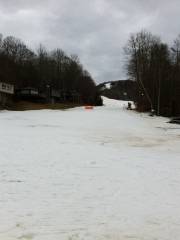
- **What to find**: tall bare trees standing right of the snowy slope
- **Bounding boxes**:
[125,31,180,116]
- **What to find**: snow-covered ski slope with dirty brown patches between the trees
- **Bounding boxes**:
[0,99,180,240]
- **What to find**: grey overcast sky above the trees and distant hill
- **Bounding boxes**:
[0,0,180,82]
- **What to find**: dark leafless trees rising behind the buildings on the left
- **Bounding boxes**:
[0,34,101,104]
